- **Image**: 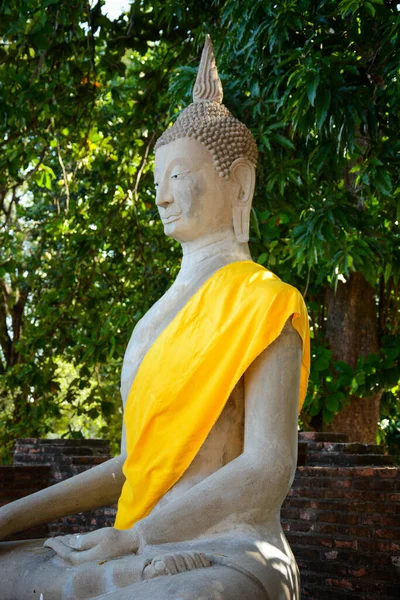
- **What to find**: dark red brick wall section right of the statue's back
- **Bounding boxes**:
[281,434,400,600]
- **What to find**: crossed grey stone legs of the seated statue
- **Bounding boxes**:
[0,537,299,600]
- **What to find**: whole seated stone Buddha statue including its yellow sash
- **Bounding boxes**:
[0,37,309,600]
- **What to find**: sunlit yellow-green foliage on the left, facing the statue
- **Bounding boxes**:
[0,2,186,460]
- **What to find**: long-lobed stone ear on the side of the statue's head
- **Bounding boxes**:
[230,158,256,244]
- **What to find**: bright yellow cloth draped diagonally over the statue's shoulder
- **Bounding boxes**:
[115,261,310,529]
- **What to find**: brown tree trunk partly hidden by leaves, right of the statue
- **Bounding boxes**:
[323,272,382,444]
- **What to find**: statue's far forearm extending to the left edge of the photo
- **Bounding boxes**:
[0,454,125,539]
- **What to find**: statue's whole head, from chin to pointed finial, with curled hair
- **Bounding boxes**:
[154,36,257,243]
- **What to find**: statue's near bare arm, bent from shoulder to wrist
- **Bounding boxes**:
[134,324,301,548]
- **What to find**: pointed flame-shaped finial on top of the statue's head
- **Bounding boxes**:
[193,34,223,104]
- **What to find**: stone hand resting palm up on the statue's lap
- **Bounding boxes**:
[44,527,139,565]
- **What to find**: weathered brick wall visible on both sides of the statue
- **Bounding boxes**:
[0,433,400,600]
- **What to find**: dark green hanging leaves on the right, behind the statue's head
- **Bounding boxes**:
[213,0,400,441]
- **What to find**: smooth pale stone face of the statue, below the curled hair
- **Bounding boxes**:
[154,137,234,243]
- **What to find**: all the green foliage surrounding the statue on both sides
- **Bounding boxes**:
[0,0,400,454]
